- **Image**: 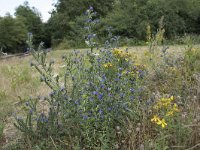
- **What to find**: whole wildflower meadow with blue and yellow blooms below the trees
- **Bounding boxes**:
[0,7,200,150]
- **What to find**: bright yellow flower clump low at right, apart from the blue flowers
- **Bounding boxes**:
[151,96,180,128]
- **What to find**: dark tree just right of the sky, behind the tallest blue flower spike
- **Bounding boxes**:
[48,0,115,47]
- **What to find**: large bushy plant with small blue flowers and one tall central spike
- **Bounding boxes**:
[15,7,145,149]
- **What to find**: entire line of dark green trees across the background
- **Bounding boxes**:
[0,0,200,53]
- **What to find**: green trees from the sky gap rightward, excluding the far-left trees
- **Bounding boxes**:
[48,0,200,45]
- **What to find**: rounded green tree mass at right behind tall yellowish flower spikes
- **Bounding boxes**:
[105,0,199,40]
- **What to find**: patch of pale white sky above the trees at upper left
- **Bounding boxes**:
[0,0,57,22]
